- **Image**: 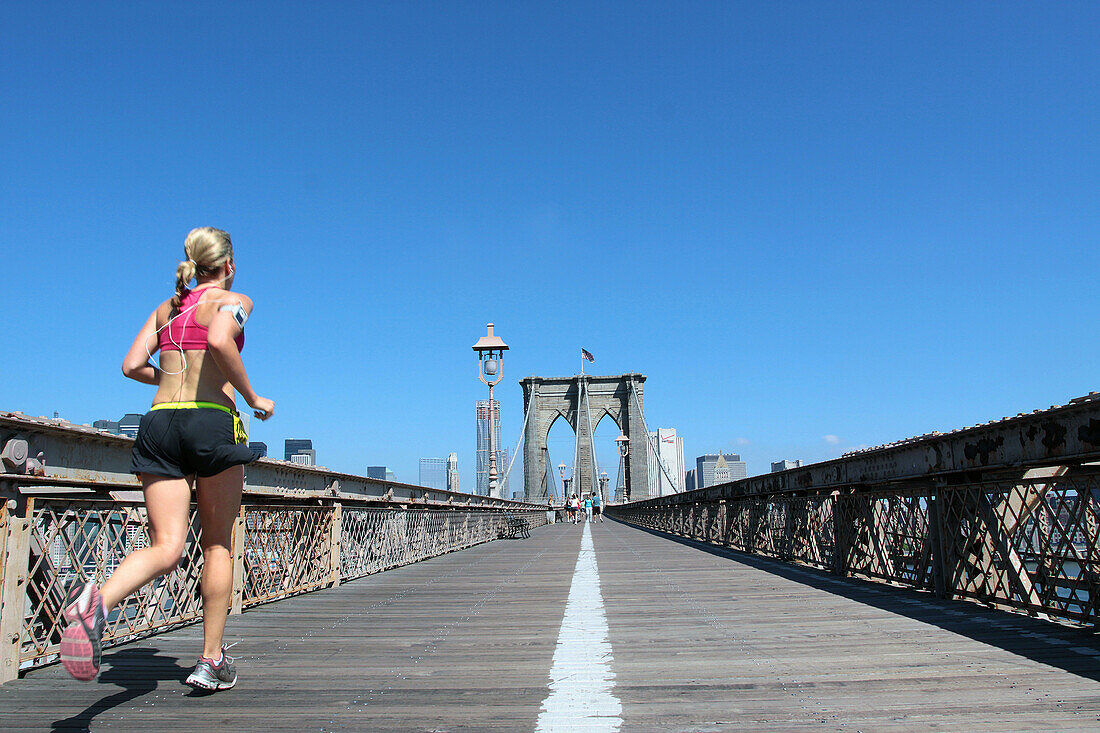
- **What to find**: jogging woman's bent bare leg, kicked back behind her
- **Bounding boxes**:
[99,473,191,611]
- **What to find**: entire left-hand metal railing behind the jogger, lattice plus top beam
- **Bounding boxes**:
[0,407,546,682]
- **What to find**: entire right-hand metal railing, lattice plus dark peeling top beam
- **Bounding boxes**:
[607,395,1100,624]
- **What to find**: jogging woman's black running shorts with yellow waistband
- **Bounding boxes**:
[130,407,253,479]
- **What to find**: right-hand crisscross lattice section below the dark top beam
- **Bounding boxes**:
[607,470,1100,623]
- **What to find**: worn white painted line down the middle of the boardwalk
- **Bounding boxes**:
[535,524,623,733]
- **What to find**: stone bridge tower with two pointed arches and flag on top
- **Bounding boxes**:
[519,373,649,502]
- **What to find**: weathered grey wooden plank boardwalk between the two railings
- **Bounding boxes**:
[0,522,1100,733]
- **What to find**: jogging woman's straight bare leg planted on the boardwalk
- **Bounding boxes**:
[198,466,244,659]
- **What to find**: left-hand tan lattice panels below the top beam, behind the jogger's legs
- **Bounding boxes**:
[0,488,546,669]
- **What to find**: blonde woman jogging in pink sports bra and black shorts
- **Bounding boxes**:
[61,227,275,690]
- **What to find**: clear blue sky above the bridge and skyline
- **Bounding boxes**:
[0,2,1100,489]
